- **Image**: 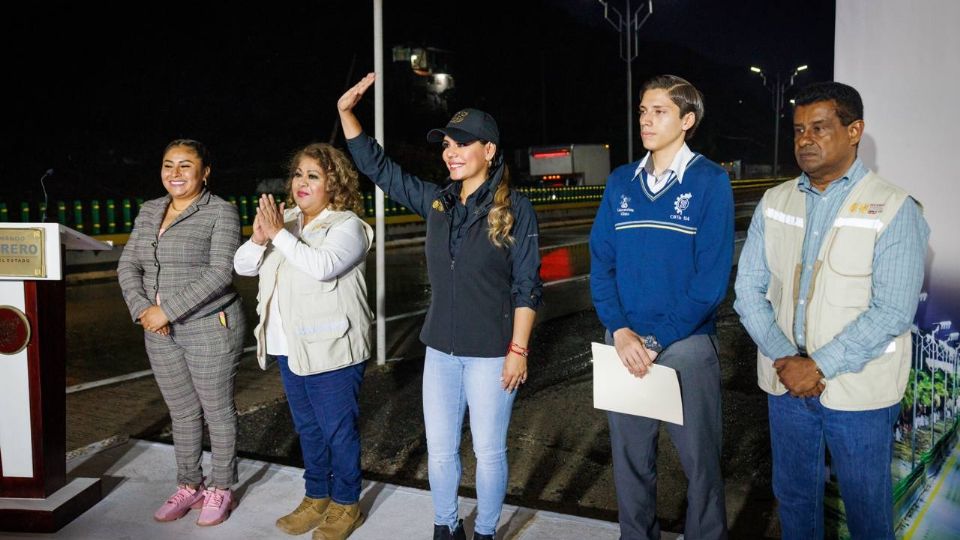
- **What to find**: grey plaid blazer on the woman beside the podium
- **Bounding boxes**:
[117,190,240,323]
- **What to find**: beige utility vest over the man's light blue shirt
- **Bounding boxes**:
[757,172,911,411]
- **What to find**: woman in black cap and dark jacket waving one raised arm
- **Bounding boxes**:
[337,73,543,540]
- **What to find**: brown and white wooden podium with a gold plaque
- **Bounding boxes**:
[0,223,111,532]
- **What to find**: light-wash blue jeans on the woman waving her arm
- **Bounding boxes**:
[423,347,516,534]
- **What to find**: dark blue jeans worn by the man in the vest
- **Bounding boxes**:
[767,394,900,540]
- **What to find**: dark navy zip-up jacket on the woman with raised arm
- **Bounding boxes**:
[347,133,543,358]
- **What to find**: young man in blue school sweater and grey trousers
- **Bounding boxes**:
[590,75,733,540]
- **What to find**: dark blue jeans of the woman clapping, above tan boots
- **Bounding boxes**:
[276,356,366,504]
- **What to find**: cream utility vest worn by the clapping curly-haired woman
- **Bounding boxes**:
[254,208,373,375]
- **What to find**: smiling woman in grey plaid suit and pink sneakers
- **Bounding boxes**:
[117,139,246,525]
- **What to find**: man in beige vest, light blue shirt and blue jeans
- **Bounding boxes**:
[734,82,929,540]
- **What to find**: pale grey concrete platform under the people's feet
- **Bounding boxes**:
[0,440,677,540]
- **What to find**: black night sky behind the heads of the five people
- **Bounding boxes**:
[0,0,834,204]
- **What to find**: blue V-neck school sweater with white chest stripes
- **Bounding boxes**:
[590,154,734,348]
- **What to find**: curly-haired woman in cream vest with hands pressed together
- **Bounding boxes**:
[234,144,373,539]
